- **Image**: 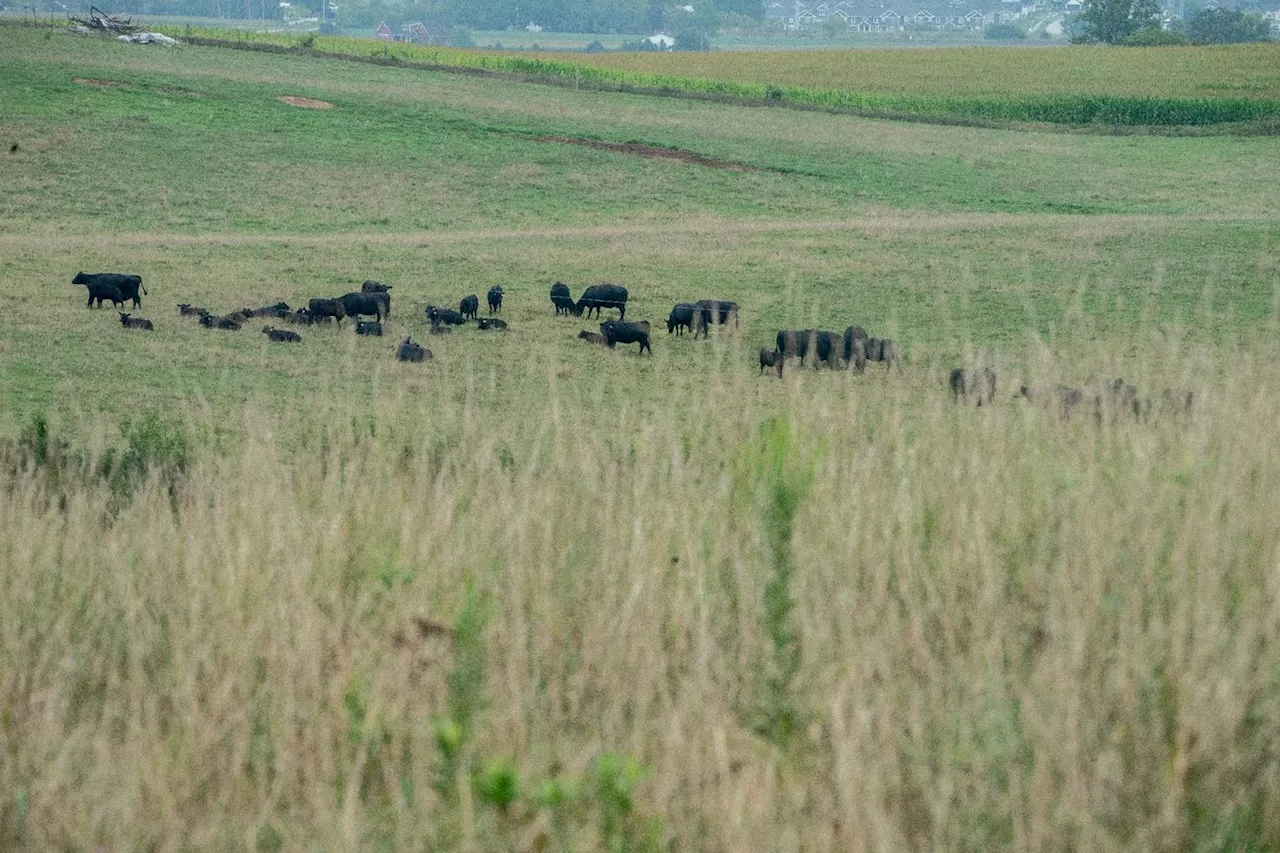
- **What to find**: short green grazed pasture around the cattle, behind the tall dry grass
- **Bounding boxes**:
[0,27,1280,430]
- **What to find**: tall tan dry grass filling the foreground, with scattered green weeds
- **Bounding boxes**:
[0,335,1280,853]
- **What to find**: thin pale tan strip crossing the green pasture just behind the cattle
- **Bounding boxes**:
[0,213,1244,250]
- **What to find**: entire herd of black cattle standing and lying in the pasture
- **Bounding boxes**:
[72,273,1194,419]
